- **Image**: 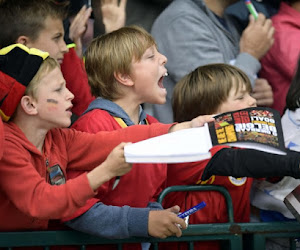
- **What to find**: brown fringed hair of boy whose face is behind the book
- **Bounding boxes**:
[172,63,251,122]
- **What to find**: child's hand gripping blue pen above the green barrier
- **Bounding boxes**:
[148,206,186,239]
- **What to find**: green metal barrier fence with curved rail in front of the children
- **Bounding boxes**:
[0,185,300,250]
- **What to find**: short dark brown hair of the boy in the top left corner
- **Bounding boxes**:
[0,0,69,48]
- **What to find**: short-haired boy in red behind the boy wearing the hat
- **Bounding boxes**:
[0,0,94,116]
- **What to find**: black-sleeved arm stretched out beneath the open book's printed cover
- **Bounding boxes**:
[201,148,300,180]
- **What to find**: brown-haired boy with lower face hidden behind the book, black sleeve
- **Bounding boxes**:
[164,64,299,250]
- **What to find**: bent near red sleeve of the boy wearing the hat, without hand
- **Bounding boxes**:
[0,141,95,220]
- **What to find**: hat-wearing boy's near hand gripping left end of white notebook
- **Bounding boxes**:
[103,142,132,177]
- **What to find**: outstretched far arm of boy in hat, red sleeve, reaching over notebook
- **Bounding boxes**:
[67,115,214,170]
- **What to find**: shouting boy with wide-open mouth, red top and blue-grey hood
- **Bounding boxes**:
[68,26,300,249]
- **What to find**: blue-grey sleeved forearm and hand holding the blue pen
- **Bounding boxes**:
[66,203,186,239]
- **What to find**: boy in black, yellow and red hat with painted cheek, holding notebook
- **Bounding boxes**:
[0,44,200,237]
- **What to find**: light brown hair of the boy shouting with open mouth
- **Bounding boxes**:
[85,25,156,100]
